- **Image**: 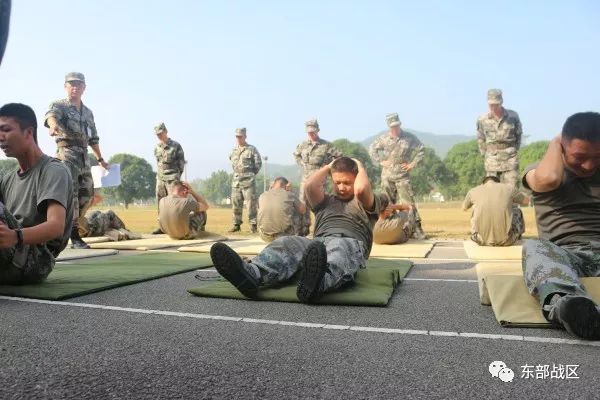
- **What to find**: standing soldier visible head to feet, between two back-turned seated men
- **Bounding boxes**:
[229,128,262,233]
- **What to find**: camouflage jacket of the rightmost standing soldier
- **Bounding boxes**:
[477,109,523,171]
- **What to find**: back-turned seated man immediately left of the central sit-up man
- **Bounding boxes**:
[258,176,306,242]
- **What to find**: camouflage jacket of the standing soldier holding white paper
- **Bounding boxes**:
[44,99,100,154]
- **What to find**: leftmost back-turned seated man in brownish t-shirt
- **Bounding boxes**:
[158,181,208,239]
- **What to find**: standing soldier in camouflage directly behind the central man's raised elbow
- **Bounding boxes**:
[294,119,342,236]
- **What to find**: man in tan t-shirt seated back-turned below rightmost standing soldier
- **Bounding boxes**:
[462,175,529,246]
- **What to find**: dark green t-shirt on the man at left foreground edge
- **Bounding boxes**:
[0,154,73,257]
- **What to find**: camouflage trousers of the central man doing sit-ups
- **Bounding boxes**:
[250,236,366,292]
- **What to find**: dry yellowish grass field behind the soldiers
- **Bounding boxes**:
[95,202,537,239]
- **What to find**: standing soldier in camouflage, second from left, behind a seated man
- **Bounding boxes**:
[152,122,185,234]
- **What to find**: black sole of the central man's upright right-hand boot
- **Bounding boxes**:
[296,242,327,303]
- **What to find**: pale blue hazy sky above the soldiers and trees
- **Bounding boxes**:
[0,0,600,179]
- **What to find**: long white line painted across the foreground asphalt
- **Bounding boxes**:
[0,296,600,347]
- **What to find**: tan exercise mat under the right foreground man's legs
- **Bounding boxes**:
[484,275,600,328]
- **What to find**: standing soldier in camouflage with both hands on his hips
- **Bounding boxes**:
[369,113,425,239]
